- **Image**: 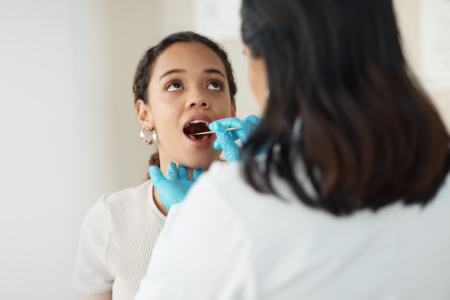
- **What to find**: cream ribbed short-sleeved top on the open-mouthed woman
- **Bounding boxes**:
[72,181,166,300]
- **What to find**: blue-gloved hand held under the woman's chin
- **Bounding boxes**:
[149,161,203,210]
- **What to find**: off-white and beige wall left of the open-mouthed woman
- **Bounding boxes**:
[0,0,158,300]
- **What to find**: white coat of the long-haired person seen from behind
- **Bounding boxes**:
[135,163,450,300]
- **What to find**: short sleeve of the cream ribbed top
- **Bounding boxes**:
[72,196,114,294]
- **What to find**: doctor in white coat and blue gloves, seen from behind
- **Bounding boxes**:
[136,0,450,300]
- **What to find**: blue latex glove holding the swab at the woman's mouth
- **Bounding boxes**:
[209,115,261,161]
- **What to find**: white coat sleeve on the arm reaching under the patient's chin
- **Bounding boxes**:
[135,174,258,300]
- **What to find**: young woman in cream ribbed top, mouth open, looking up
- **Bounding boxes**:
[72,32,236,300]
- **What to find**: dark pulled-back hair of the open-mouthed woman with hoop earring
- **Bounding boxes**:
[133,31,237,180]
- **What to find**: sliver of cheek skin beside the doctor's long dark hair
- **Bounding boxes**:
[244,46,269,111]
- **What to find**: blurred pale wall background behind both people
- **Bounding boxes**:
[0,0,450,300]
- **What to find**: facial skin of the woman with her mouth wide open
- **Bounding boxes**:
[136,42,236,215]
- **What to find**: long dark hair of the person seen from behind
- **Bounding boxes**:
[241,0,450,216]
